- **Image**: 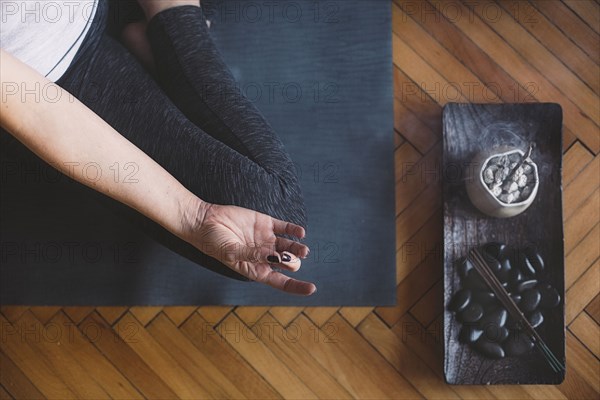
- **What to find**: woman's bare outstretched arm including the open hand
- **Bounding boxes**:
[0,50,315,294]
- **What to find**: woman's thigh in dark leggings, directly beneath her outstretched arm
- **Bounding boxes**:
[54,31,305,278]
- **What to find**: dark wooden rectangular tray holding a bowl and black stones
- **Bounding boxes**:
[442,103,565,384]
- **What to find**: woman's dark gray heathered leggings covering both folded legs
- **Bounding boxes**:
[3,0,306,279]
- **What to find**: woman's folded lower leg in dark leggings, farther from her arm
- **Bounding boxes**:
[147,1,299,190]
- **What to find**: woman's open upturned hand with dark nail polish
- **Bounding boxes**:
[184,202,317,296]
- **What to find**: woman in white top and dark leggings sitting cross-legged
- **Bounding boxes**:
[0,0,316,295]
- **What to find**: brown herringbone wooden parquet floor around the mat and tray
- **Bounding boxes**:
[0,0,600,399]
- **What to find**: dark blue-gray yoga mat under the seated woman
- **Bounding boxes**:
[0,0,395,306]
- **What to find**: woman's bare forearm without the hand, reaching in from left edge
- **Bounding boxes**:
[0,51,205,240]
